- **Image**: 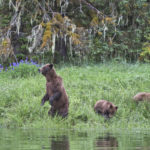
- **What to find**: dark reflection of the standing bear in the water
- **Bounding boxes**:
[51,135,69,150]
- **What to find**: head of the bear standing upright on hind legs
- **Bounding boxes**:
[38,64,56,81]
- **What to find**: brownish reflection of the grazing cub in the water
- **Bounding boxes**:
[95,134,118,150]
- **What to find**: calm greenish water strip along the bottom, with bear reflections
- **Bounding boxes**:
[0,129,150,150]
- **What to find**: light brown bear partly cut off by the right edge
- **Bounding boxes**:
[133,92,150,102]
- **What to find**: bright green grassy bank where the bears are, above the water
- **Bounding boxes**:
[0,63,150,129]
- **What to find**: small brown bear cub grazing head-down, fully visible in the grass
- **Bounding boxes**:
[94,100,118,118]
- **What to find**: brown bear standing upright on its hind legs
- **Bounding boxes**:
[39,64,69,118]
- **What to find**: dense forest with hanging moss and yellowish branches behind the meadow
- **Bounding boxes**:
[0,0,150,64]
